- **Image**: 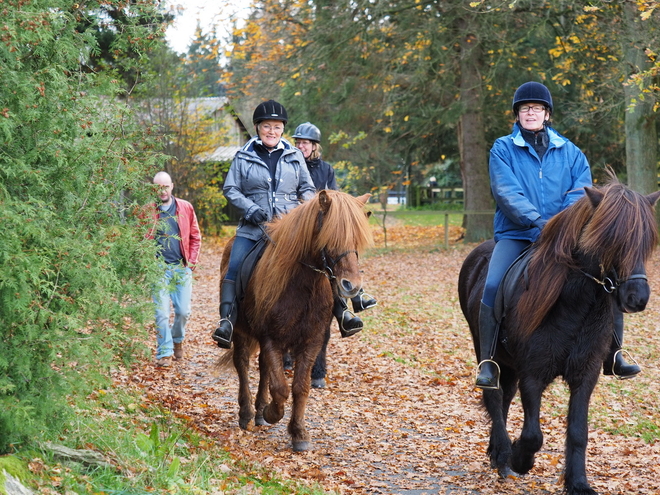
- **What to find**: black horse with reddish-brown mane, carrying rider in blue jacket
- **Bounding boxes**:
[458,177,660,495]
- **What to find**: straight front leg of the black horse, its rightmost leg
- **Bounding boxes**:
[564,374,600,495]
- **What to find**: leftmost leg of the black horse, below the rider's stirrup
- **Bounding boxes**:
[483,368,516,478]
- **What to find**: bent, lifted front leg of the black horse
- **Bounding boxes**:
[511,377,547,474]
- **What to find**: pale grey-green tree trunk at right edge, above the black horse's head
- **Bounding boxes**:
[622,0,658,194]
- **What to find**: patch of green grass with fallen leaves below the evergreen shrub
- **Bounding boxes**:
[11,380,326,495]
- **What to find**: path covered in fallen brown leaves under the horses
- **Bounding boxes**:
[130,227,660,495]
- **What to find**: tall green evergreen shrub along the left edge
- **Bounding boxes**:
[0,0,168,453]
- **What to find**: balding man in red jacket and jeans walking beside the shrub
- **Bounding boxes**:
[149,172,202,367]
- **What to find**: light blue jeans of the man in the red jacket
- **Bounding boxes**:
[153,265,192,359]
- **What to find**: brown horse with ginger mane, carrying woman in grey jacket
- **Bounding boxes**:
[219,190,373,451]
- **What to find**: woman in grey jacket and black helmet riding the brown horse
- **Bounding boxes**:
[213,100,316,349]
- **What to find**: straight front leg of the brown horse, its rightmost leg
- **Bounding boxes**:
[288,342,321,452]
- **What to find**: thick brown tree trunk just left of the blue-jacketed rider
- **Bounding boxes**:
[457,19,493,242]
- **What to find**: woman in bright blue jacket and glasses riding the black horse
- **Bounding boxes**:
[476,82,640,389]
